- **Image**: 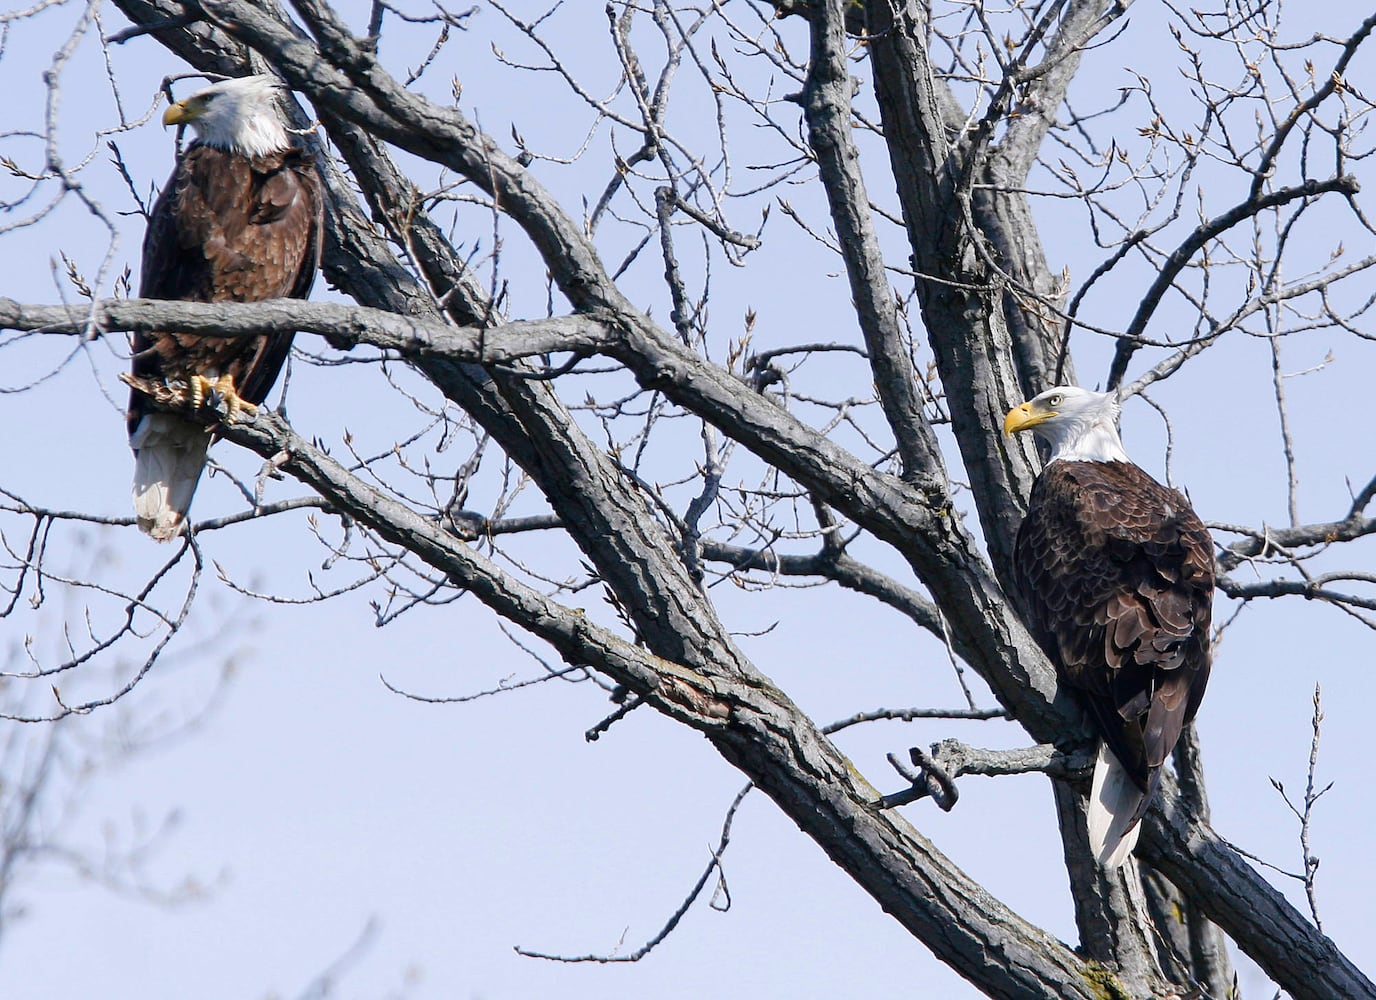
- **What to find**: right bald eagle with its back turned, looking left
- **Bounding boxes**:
[1003,387,1214,868]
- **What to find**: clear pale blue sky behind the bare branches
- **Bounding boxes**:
[0,3,1376,1000]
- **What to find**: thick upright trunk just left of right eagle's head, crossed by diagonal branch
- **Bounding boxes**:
[867,0,1153,968]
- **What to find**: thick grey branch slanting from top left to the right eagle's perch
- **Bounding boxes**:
[147,0,1060,742]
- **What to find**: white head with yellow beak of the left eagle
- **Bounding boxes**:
[162,76,292,157]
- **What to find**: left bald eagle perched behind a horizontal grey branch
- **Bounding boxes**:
[122,76,323,542]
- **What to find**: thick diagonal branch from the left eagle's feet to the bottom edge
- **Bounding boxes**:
[224,413,1117,1000]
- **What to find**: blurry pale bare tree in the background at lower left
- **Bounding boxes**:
[0,545,242,944]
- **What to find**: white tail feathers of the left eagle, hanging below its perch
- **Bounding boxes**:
[129,413,211,542]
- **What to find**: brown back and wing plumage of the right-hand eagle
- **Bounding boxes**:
[1014,461,1214,807]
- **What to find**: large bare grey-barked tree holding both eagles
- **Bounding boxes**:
[0,0,1376,1000]
